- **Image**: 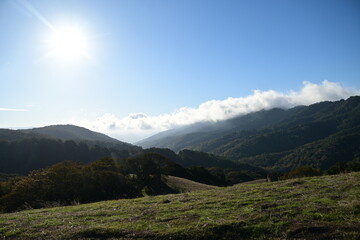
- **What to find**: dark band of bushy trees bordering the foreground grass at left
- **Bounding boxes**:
[0,153,242,212]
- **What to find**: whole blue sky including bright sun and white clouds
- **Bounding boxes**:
[0,0,360,142]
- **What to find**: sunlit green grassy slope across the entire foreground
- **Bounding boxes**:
[0,173,360,239]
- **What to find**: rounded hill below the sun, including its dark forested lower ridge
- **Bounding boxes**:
[0,125,142,174]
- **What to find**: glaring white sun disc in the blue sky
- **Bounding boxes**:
[47,26,91,62]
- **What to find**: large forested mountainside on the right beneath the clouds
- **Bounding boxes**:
[137,96,360,171]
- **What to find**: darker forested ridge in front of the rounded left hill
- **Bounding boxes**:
[0,138,130,174]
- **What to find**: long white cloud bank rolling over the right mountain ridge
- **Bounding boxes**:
[71,80,360,142]
